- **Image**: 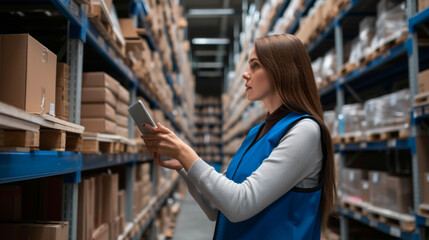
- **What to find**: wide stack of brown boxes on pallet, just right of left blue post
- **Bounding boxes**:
[81,72,119,134]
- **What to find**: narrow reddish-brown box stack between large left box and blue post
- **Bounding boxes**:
[55,63,70,121]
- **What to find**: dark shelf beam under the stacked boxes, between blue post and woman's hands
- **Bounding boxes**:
[82,153,150,171]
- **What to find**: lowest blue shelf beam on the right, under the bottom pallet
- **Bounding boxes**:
[338,207,420,240]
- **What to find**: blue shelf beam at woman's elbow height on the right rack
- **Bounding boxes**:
[334,137,416,152]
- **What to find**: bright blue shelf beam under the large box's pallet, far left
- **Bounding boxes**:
[0,151,82,183]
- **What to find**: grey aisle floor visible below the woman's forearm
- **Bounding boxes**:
[173,193,216,240]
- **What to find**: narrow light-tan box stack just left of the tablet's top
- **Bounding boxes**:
[116,85,130,138]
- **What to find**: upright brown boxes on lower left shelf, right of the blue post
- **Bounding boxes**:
[77,174,120,240]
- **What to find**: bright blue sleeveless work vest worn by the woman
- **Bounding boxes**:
[214,113,326,240]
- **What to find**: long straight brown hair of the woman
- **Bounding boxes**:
[255,34,337,232]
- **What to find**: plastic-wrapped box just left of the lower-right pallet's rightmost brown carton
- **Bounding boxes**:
[369,171,387,208]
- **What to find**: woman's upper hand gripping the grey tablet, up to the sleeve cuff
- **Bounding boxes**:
[142,123,199,171]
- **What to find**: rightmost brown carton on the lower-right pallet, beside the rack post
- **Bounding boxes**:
[385,176,413,213]
